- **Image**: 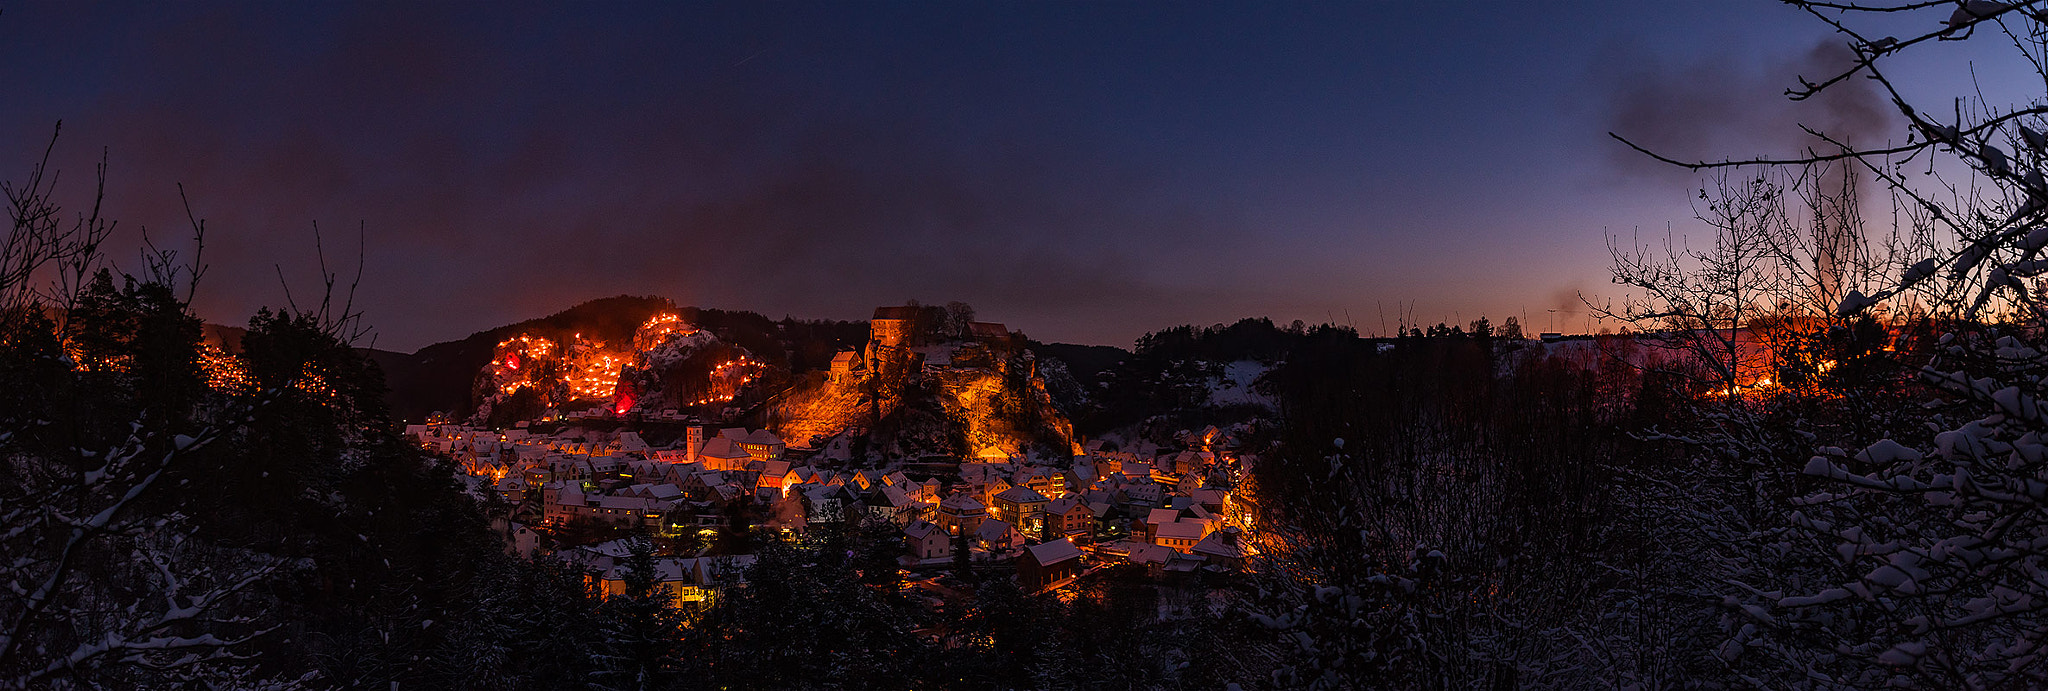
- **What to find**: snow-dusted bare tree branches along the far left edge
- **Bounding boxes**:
[0,127,303,689]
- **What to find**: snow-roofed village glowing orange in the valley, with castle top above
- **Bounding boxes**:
[406,308,1257,607]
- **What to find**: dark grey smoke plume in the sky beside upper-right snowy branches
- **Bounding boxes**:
[1595,37,1898,185]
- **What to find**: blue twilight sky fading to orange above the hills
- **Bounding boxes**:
[0,0,1998,351]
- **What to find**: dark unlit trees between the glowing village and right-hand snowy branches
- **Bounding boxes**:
[1255,330,1659,689]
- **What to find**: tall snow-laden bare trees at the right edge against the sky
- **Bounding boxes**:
[1616,0,2048,689]
